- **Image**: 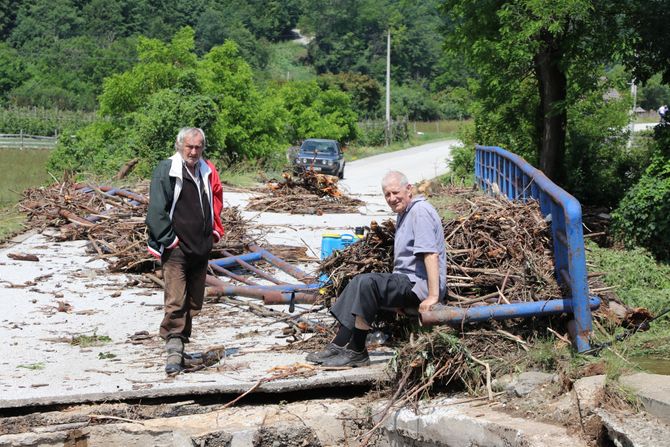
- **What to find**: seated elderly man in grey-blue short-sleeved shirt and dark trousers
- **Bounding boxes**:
[307,171,447,367]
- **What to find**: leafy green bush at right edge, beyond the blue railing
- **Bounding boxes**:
[613,156,670,261]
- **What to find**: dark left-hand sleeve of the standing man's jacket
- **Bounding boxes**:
[146,163,179,258]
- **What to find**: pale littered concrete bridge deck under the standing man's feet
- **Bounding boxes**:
[0,231,389,408]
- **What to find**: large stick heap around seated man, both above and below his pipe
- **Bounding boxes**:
[320,192,640,434]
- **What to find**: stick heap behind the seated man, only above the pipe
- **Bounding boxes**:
[320,193,562,306]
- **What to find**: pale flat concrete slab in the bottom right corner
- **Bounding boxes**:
[619,373,670,424]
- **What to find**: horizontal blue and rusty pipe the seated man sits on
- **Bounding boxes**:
[421,297,600,326]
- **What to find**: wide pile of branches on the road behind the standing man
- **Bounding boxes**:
[19,182,255,273]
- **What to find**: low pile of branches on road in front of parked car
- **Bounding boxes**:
[247,170,363,216]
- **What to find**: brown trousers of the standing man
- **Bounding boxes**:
[160,247,207,341]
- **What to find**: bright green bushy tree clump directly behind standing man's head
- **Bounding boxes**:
[51,28,356,175]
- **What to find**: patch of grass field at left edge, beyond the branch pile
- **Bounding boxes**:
[0,149,51,207]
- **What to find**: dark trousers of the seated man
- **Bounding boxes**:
[330,273,421,329]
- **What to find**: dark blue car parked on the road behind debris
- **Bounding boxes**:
[293,138,345,178]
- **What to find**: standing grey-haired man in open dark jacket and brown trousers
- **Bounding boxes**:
[146,127,223,374]
